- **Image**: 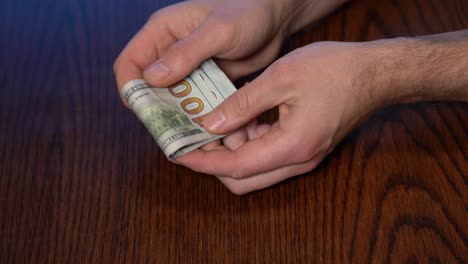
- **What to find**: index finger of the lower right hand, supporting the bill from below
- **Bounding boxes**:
[178,128,297,178]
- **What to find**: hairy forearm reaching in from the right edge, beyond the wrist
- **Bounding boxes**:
[367,30,468,104]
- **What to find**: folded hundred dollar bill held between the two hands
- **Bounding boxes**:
[121,59,236,159]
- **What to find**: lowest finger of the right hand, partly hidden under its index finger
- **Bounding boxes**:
[217,160,321,195]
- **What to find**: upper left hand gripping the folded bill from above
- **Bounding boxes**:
[114,0,286,89]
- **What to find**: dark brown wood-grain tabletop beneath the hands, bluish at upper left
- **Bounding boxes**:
[0,0,468,263]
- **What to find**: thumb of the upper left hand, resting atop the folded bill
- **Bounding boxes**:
[143,18,234,87]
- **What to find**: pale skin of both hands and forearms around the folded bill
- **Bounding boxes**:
[114,0,468,194]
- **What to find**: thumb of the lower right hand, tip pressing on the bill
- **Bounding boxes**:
[203,69,288,134]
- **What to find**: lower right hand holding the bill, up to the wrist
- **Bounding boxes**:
[177,42,388,194]
